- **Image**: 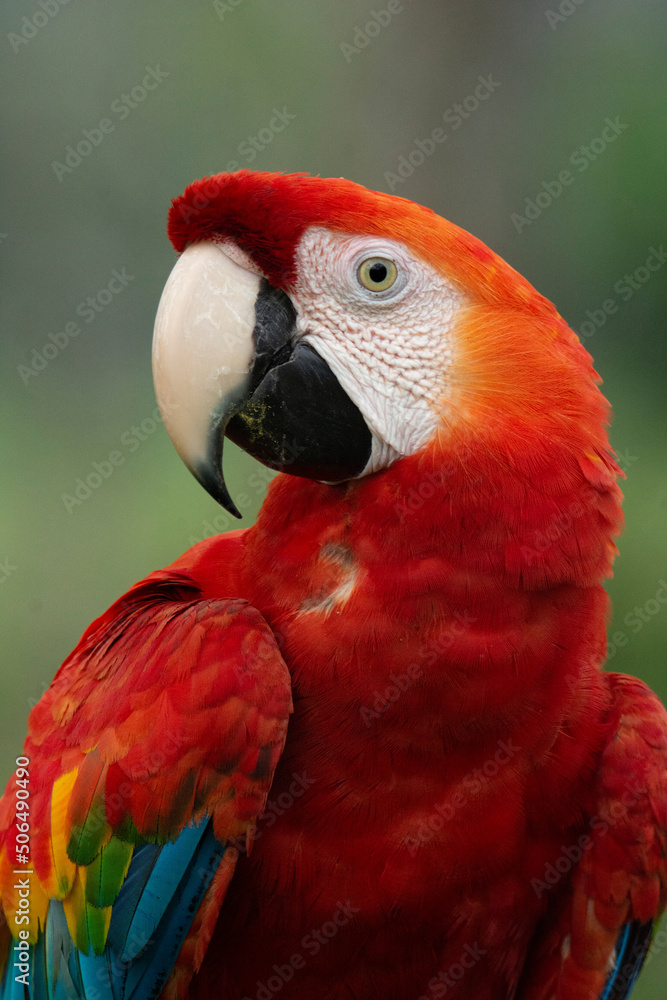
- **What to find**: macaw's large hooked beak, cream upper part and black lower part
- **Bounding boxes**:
[153,241,372,517]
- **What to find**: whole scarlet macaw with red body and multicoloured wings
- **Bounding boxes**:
[0,169,667,1000]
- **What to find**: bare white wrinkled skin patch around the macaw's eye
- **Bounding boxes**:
[290,226,466,474]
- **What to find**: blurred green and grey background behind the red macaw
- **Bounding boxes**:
[0,0,667,1000]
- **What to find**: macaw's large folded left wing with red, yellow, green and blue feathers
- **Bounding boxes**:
[0,570,291,1000]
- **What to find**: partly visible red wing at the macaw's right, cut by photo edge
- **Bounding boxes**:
[519,674,667,1000]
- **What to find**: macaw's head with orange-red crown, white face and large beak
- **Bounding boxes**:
[154,170,620,540]
